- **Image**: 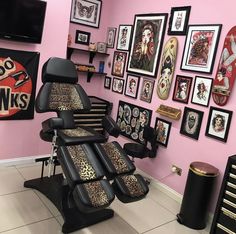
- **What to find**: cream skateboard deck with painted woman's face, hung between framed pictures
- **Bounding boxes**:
[157,37,178,100]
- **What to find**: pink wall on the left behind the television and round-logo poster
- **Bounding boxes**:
[0,0,71,159]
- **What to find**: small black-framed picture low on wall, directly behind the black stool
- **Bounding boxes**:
[155,118,172,147]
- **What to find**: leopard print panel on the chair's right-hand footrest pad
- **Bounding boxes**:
[121,175,145,197]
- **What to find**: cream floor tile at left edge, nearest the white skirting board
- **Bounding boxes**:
[0,167,27,195]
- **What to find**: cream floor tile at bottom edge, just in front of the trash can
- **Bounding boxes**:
[145,221,199,234]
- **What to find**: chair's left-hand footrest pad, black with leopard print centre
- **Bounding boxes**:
[73,180,115,213]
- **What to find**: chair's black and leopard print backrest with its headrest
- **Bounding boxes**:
[36,57,91,128]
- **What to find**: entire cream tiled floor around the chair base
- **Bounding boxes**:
[0,164,212,234]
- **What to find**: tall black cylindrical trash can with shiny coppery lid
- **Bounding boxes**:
[177,162,219,230]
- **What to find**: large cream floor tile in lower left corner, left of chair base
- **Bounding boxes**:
[0,190,52,232]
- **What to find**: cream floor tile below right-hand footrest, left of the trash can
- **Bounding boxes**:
[111,197,176,233]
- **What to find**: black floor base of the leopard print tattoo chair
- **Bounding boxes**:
[24,174,114,233]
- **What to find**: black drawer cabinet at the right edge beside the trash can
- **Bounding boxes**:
[210,155,236,234]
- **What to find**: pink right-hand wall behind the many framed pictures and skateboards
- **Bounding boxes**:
[70,0,236,209]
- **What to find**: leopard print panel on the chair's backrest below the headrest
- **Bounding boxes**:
[49,83,84,111]
